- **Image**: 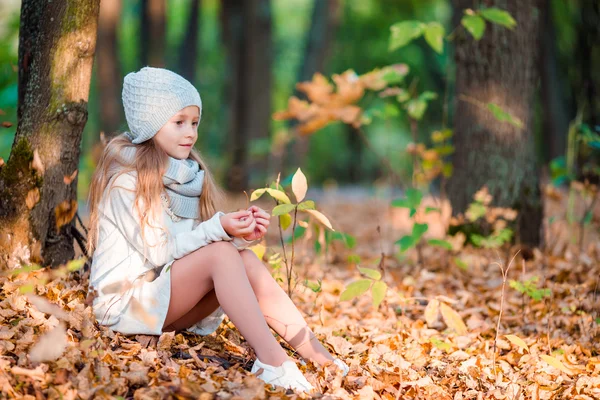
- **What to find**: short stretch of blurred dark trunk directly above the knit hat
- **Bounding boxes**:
[140,0,166,68]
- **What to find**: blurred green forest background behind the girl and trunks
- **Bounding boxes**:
[0,0,600,199]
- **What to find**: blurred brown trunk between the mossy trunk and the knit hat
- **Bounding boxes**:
[96,0,123,137]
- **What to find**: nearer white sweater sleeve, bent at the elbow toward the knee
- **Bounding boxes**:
[103,174,232,267]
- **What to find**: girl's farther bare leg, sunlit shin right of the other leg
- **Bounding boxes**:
[238,250,333,365]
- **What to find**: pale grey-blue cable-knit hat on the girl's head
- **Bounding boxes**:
[122,67,202,144]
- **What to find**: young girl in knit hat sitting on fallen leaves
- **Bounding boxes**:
[89,67,348,392]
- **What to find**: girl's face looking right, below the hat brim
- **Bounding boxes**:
[154,106,200,160]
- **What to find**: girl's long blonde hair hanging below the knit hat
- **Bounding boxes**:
[87,134,223,255]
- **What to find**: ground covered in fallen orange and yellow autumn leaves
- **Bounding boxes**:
[0,188,600,400]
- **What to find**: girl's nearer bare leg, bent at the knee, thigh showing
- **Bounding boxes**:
[164,242,289,366]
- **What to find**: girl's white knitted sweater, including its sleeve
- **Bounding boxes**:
[89,173,252,335]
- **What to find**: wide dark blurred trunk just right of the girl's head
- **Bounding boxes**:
[221,0,272,191]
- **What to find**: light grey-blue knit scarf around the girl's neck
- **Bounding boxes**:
[120,146,204,219]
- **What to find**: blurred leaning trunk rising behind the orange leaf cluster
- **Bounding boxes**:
[286,0,341,172]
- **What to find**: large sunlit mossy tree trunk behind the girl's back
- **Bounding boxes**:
[0,0,100,269]
